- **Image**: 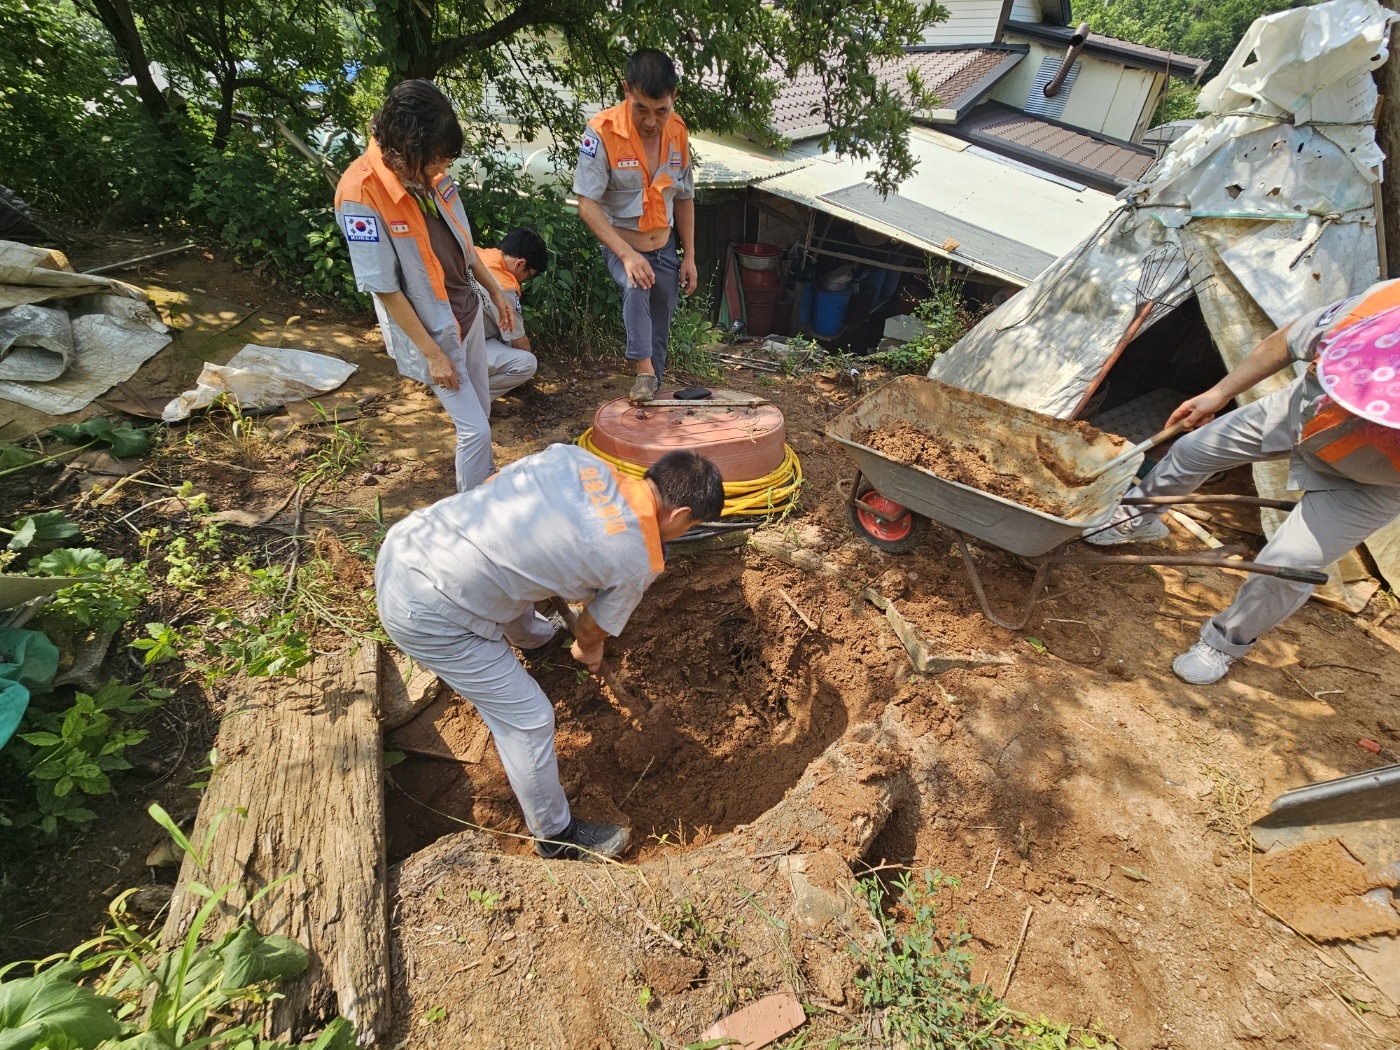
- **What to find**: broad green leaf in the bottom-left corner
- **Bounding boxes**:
[0,967,122,1050]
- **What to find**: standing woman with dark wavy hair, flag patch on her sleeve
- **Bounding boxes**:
[336,80,510,493]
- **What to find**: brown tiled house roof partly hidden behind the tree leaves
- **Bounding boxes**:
[770,45,1028,140]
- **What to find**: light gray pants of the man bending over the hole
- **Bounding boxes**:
[377,571,571,839]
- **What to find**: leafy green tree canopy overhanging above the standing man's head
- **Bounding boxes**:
[361,0,948,185]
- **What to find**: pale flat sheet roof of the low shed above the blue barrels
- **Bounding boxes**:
[755,127,1117,286]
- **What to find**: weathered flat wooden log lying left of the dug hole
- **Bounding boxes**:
[164,643,391,1044]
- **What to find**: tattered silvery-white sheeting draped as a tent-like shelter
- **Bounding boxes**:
[928,0,1400,596]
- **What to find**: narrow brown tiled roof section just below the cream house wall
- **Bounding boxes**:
[948,102,1156,193]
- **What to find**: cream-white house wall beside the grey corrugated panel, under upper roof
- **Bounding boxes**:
[991,34,1166,141]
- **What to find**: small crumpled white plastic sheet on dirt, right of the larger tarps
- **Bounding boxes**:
[161,350,358,423]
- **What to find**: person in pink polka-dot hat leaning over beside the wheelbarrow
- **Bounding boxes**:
[1085,280,1400,686]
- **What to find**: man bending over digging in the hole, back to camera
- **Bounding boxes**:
[374,445,724,860]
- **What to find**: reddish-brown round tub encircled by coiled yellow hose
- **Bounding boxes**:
[592,388,785,482]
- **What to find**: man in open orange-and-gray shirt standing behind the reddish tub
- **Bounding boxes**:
[574,48,699,402]
